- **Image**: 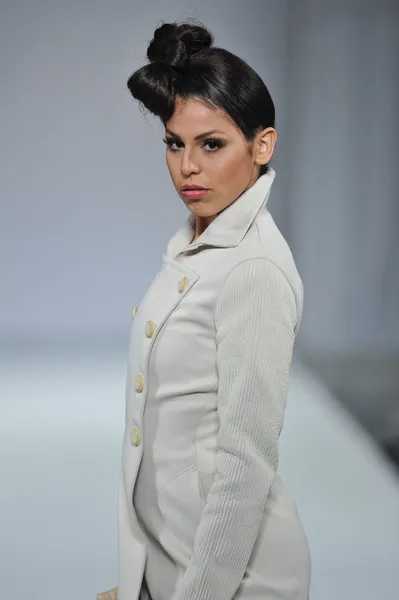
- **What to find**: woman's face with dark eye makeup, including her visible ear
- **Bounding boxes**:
[164,97,276,234]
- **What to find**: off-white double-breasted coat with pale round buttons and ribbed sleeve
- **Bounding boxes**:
[118,169,310,600]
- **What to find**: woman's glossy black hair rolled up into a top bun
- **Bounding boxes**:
[127,22,275,175]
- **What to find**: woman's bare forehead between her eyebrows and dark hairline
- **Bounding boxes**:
[166,96,238,136]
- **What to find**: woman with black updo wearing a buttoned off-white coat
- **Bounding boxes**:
[98,18,310,600]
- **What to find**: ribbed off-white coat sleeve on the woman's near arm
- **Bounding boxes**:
[172,258,298,600]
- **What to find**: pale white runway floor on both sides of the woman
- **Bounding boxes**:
[0,347,399,600]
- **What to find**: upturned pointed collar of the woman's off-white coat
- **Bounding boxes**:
[166,167,276,258]
